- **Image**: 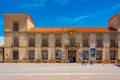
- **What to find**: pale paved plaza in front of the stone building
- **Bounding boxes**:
[0,63,120,80]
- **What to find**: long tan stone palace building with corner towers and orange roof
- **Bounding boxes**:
[4,14,120,63]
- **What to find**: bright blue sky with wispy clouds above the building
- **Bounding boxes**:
[0,0,120,44]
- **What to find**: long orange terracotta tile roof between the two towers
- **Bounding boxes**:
[28,28,116,33]
